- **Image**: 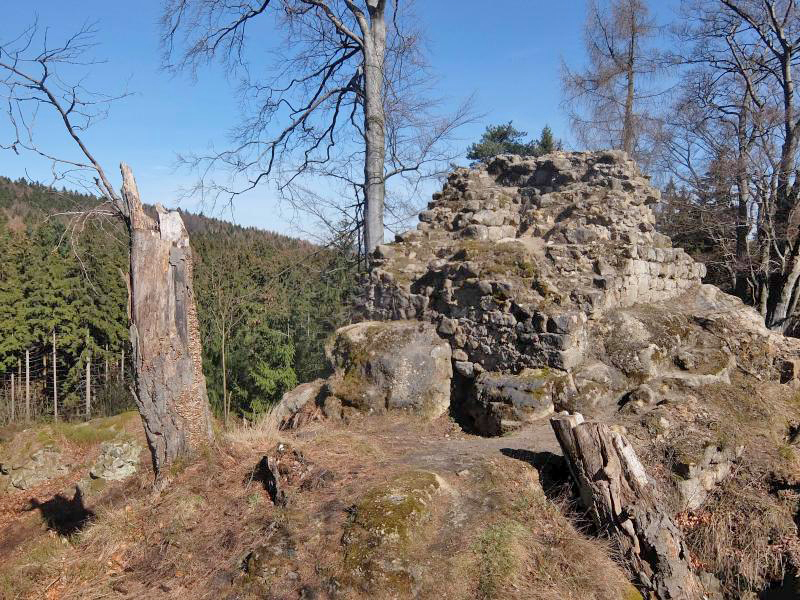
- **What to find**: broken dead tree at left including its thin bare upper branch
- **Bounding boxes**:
[0,25,211,476]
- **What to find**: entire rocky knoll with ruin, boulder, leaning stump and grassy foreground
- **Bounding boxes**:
[0,152,800,600]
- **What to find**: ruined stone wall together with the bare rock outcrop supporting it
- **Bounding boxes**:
[358,152,796,435]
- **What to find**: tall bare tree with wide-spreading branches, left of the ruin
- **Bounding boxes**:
[162,0,471,252]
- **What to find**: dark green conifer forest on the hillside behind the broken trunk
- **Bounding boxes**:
[0,178,353,419]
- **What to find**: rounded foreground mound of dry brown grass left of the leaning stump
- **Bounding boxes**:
[0,417,637,600]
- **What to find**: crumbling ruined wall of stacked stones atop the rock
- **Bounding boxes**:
[359,152,705,377]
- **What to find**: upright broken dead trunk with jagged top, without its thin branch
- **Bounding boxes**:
[121,164,211,476]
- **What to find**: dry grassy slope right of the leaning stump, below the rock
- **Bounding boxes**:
[626,374,800,597]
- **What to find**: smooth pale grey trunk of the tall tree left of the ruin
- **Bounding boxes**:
[363,0,386,253]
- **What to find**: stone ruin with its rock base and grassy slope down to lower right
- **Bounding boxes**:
[336,152,800,597]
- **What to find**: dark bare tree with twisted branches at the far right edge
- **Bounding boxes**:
[672,0,800,331]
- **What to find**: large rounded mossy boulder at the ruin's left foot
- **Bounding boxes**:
[326,321,453,418]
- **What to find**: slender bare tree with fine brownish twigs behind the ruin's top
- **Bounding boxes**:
[562,0,663,162]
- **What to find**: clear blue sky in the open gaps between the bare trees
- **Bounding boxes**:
[0,0,671,234]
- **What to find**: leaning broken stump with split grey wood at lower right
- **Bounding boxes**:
[550,414,703,600]
